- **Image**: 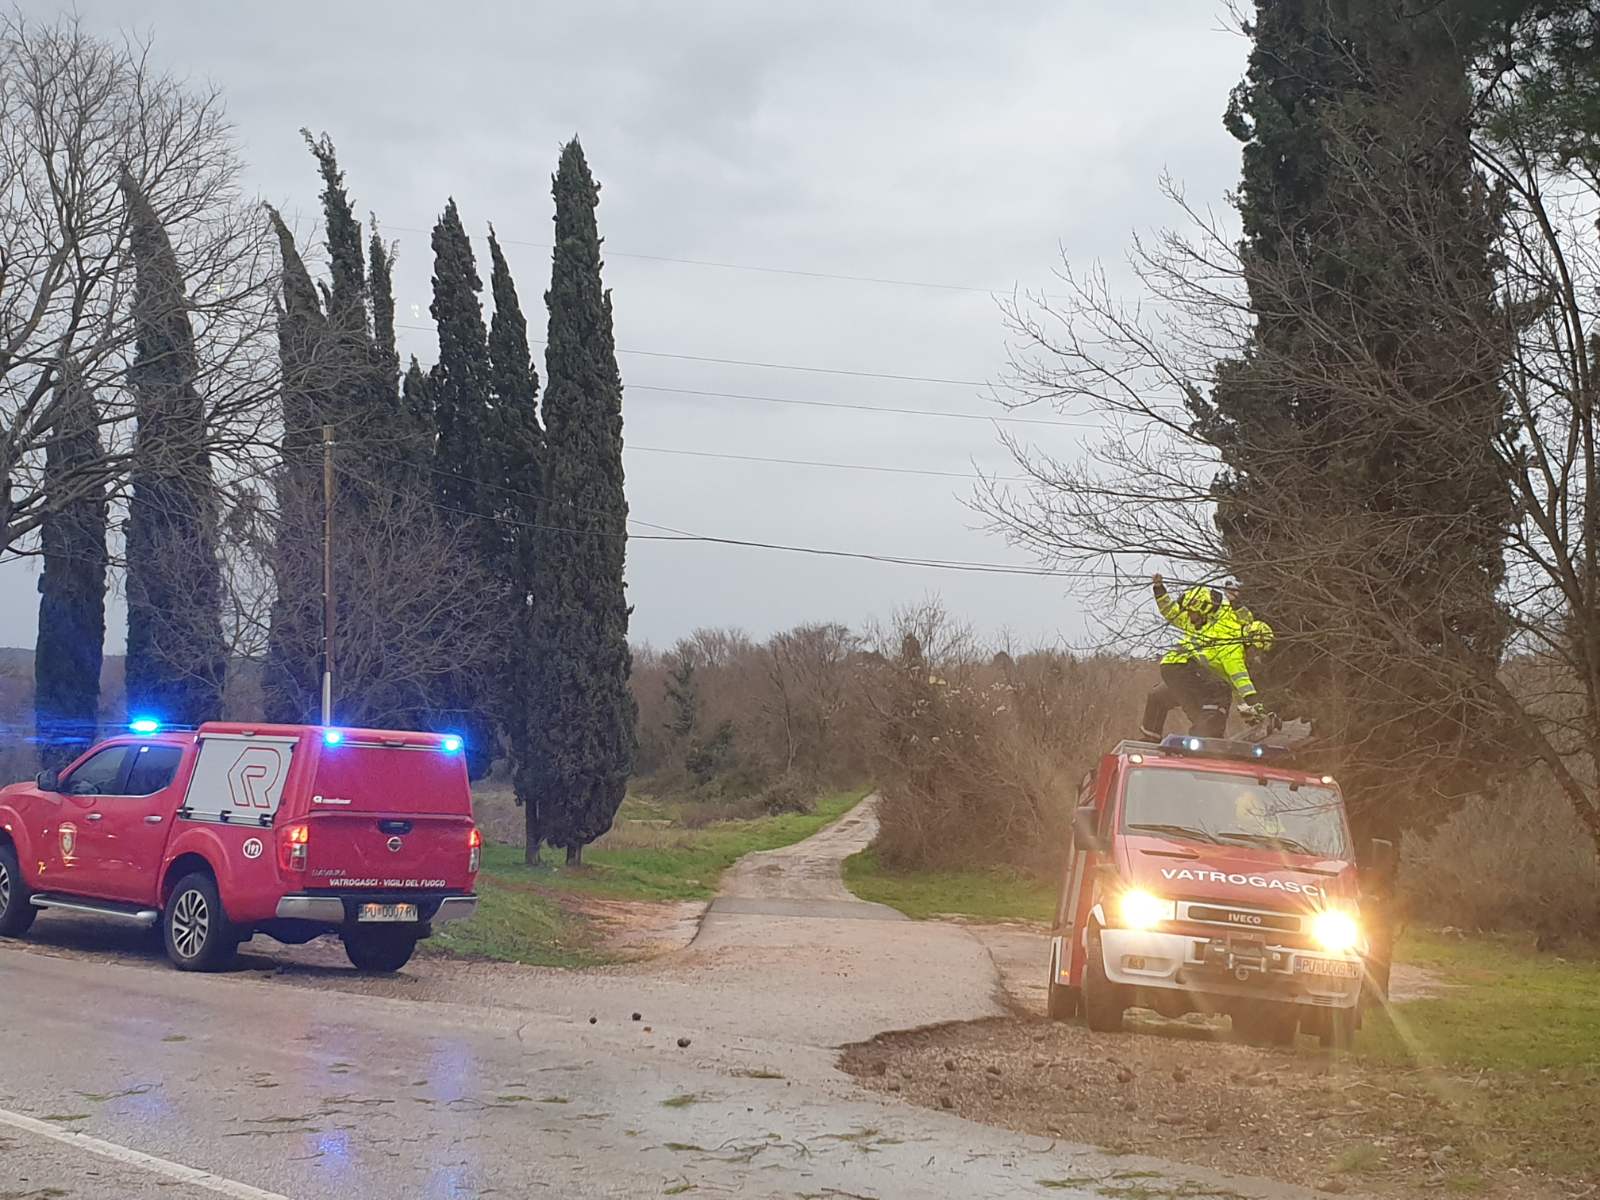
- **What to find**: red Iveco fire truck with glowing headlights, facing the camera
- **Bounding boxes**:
[1048,734,1387,1046]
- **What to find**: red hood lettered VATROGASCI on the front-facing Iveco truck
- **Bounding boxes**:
[1118,834,1357,910]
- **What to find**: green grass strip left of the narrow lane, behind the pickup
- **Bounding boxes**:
[430,790,864,966]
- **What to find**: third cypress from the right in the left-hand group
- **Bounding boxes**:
[429,200,502,778]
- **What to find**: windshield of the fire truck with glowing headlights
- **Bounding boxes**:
[1122,768,1350,859]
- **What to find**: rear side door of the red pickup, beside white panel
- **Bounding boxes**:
[86,742,184,904]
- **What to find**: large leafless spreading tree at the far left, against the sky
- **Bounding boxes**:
[0,10,277,566]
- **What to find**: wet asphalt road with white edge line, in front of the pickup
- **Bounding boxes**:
[0,810,1294,1200]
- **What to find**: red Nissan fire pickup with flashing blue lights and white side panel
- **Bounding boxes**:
[0,720,483,971]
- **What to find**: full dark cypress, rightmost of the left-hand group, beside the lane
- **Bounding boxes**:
[526,138,638,862]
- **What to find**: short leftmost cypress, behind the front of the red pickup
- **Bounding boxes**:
[34,362,106,768]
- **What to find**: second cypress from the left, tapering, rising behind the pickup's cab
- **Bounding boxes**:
[122,173,227,723]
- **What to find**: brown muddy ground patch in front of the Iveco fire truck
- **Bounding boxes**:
[840,1013,1580,1200]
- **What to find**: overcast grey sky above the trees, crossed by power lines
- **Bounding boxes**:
[0,0,1246,650]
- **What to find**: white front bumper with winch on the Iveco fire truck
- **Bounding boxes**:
[1101,930,1362,1008]
